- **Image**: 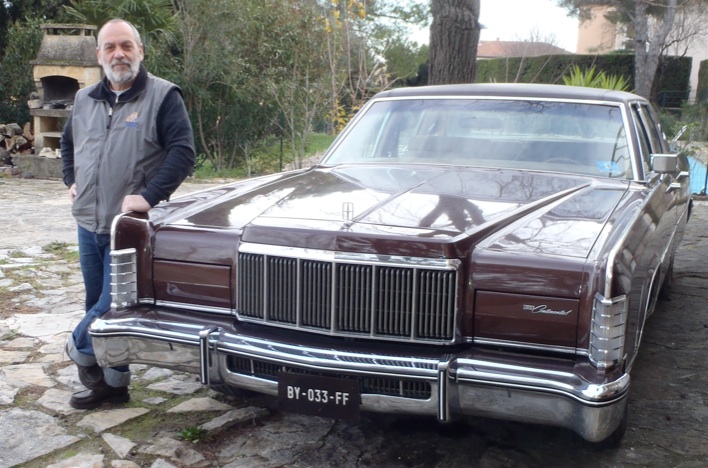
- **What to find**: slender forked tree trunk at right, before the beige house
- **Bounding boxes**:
[634,0,676,99]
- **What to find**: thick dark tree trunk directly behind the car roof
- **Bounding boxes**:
[428,0,480,84]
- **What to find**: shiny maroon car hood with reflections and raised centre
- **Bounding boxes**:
[158,165,627,258]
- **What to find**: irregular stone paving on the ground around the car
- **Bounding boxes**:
[0,179,708,468]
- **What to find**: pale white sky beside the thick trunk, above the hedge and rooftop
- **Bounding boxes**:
[412,0,578,52]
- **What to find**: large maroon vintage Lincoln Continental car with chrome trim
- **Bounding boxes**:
[91,84,690,445]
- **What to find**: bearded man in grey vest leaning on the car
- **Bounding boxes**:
[61,19,195,409]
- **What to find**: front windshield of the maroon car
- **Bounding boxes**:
[324,99,632,178]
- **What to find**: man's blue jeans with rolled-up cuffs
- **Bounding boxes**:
[67,226,130,387]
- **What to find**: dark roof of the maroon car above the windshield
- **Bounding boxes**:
[374,83,648,103]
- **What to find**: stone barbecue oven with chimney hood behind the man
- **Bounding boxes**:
[30,24,102,155]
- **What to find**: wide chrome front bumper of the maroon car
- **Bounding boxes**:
[90,307,629,442]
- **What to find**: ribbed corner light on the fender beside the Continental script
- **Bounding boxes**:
[589,293,627,369]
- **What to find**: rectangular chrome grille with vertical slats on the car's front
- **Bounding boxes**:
[237,253,457,342]
